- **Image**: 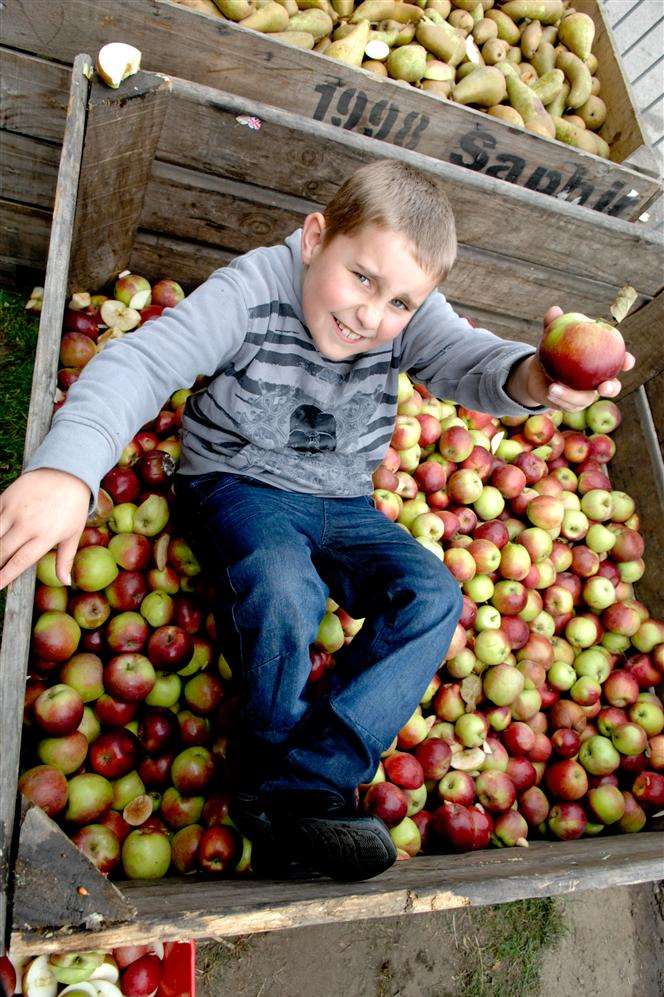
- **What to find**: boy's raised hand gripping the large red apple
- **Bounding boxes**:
[506,307,636,412]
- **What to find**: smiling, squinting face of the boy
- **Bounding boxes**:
[302,212,436,360]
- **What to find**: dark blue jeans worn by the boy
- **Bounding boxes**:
[176,473,462,799]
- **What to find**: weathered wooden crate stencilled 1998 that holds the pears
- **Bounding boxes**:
[0,0,661,296]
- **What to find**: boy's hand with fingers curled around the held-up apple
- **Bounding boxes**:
[507,306,636,412]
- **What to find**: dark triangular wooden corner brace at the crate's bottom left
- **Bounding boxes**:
[12,801,136,931]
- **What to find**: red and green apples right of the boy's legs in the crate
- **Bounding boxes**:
[361,375,664,858]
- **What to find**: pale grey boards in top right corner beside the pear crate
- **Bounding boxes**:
[601,0,664,168]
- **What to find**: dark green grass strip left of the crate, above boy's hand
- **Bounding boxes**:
[0,288,39,621]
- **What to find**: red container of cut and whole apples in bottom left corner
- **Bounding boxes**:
[0,942,191,997]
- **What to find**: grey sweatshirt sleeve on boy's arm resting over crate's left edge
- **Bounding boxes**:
[24,267,248,501]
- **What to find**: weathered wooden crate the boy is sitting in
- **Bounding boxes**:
[0,56,664,955]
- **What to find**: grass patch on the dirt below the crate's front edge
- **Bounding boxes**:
[455,897,568,997]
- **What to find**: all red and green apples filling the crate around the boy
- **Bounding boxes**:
[20,274,664,879]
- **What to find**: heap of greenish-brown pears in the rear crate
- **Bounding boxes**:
[175,0,609,158]
